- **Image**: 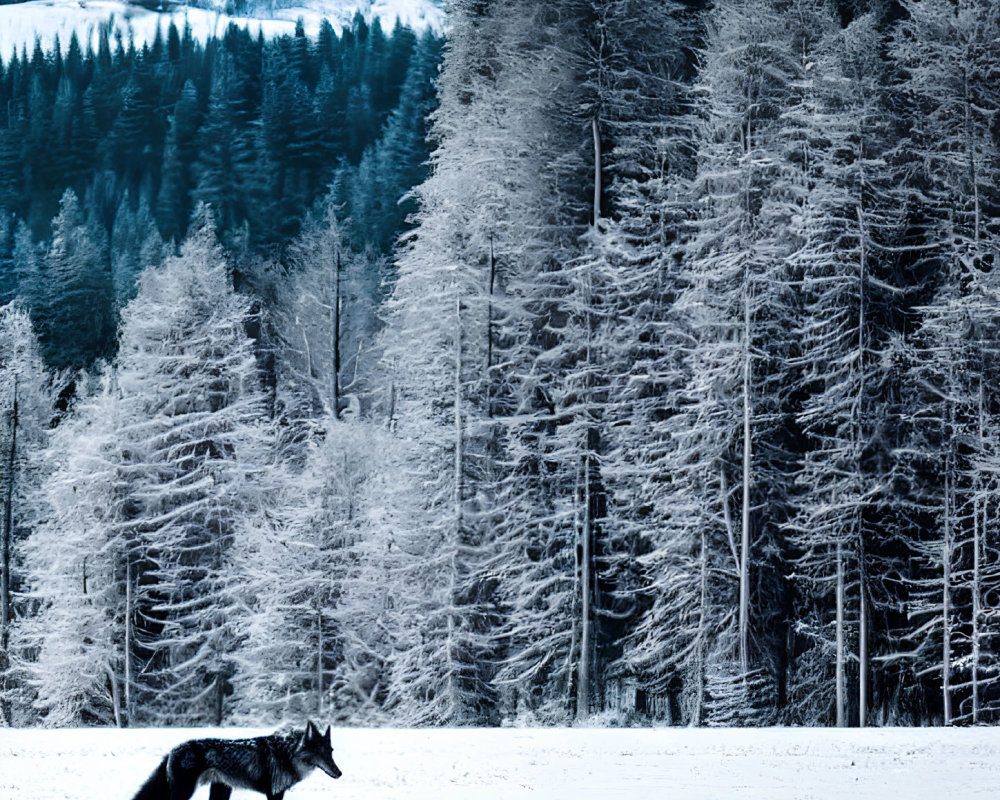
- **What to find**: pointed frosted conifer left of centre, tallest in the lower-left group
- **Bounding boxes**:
[116,212,264,724]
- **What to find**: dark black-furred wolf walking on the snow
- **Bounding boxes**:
[132,721,342,800]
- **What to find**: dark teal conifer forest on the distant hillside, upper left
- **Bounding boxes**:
[0,10,440,367]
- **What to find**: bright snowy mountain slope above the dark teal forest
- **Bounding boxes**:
[0,0,444,63]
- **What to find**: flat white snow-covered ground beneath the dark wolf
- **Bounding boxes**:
[0,728,1000,800]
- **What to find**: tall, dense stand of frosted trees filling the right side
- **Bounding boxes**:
[383,0,1000,725]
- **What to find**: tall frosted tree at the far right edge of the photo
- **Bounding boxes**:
[892,0,1000,725]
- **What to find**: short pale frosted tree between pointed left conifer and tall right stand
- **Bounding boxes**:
[233,417,393,722]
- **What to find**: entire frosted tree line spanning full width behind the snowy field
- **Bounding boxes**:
[0,0,1000,725]
